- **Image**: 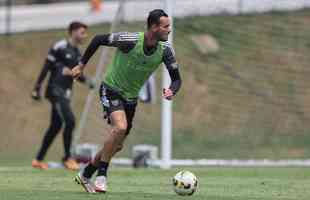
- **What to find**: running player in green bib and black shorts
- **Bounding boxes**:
[72,9,181,193]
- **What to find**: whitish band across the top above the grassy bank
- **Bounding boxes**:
[0,0,310,33]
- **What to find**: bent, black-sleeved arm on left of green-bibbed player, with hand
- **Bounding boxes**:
[72,32,139,78]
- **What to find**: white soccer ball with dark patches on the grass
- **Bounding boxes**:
[172,171,198,196]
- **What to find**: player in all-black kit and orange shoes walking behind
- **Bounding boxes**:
[32,22,94,170]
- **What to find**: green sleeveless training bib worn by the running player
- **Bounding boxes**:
[104,32,164,99]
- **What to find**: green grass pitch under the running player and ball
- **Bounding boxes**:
[0,166,310,200]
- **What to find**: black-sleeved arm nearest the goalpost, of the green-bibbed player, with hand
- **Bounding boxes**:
[163,45,182,100]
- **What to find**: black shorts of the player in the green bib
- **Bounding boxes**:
[99,83,137,133]
